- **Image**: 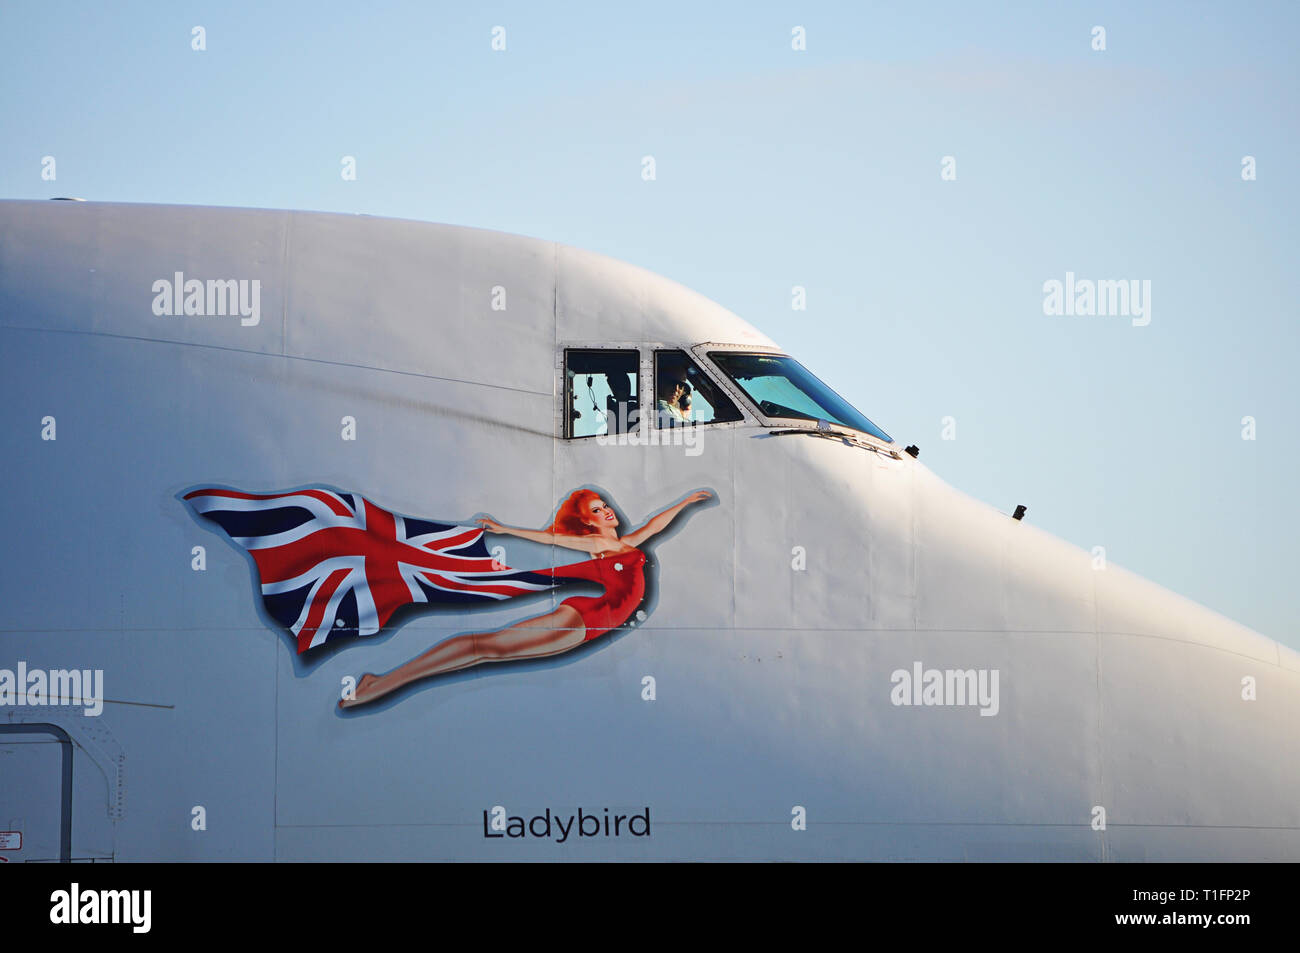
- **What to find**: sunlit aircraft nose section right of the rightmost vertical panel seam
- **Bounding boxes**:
[1097,568,1300,861]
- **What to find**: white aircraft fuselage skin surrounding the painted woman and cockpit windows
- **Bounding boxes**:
[0,203,1300,861]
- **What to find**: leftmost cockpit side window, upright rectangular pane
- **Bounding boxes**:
[564,350,641,437]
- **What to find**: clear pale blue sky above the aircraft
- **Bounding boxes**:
[0,0,1300,647]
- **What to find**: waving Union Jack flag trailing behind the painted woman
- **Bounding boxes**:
[182,486,569,654]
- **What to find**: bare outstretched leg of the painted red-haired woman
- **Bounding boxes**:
[338,606,586,709]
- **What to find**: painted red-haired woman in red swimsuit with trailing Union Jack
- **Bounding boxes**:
[181,486,712,707]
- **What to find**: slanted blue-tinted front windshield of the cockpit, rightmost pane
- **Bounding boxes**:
[709,351,893,443]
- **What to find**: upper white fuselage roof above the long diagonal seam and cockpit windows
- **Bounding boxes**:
[0,202,774,377]
